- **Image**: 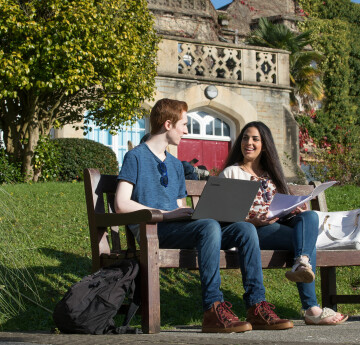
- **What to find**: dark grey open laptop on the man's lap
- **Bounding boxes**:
[171,176,260,223]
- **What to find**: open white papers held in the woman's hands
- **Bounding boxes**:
[268,181,337,219]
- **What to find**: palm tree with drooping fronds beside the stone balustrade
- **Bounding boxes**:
[247,18,323,107]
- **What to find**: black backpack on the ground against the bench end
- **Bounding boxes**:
[53,259,140,334]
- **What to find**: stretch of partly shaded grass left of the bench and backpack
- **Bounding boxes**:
[0,182,90,330]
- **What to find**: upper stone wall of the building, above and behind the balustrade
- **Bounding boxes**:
[148,0,301,43]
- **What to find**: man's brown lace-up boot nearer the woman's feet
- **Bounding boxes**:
[246,301,294,330]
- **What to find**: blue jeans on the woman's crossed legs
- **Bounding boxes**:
[257,211,319,310]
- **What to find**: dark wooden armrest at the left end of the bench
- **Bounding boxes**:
[95,209,163,227]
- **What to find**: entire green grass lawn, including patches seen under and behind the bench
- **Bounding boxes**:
[0,182,360,331]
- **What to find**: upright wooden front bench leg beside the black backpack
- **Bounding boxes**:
[140,224,160,334]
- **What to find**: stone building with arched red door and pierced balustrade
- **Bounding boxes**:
[55,0,300,180]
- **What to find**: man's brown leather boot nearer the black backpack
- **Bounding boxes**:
[202,302,252,333]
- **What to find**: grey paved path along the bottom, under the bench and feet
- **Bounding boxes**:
[0,317,360,345]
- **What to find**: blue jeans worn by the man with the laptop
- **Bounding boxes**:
[158,219,265,311]
